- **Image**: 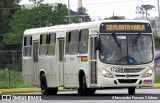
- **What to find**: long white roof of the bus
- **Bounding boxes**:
[24,20,149,35]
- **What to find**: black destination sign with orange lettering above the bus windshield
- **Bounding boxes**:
[100,22,152,33]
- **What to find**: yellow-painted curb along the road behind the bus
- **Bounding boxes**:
[0,83,160,94]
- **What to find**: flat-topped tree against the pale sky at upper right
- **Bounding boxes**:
[136,4,155,18]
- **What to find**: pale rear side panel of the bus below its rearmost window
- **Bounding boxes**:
[22,58,34,86]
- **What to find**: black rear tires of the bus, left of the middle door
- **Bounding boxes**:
[40,74,58,95]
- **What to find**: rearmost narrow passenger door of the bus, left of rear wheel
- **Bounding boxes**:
[33,41,39,85]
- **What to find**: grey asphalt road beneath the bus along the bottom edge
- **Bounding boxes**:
[0,89,160,103]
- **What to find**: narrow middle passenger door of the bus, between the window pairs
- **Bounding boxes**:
[58,39,64,86]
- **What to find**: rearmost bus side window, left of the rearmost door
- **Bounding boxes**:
[23,36,32,56]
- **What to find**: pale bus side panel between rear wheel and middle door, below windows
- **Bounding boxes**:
[39,56,57,87]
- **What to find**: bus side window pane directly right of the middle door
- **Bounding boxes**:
[68,30,79,54]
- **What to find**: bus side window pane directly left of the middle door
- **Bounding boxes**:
[48,33,56,55]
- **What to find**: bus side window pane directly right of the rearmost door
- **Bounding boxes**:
[39,34,47,55]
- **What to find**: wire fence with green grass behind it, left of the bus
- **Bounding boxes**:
[0,50,23,88]
